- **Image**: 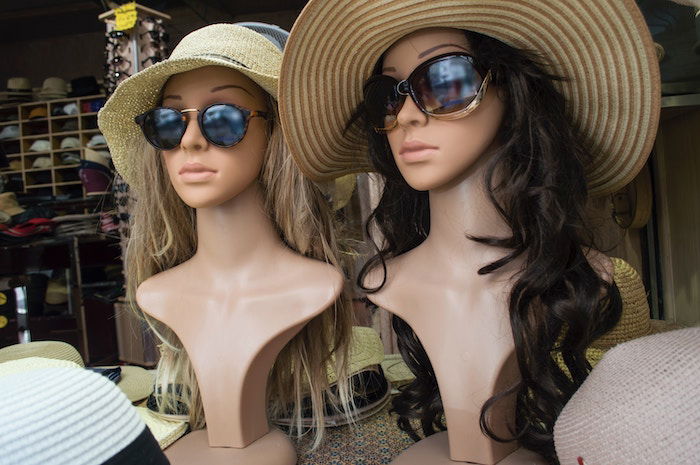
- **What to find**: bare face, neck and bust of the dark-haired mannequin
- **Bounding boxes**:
[360,28,612,465]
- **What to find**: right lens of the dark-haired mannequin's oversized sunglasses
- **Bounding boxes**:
[411,55,482,115]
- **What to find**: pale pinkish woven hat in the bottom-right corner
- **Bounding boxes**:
[554,327,700,465]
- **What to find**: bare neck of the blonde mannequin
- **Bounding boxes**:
[193,182,287,271]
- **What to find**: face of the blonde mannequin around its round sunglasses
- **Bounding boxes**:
[161,66,267,208]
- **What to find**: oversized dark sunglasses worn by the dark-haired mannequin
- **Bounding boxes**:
[364,53,491,133]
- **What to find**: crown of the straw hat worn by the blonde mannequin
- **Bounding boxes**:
[169,24,282,80]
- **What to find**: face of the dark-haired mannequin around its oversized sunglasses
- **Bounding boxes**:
[382,28,504,191]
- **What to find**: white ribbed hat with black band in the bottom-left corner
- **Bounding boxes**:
[0,367,169,465]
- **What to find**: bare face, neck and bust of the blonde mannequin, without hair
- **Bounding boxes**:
[136,67,343,464]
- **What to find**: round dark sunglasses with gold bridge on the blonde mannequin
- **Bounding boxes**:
[134,103,268,150]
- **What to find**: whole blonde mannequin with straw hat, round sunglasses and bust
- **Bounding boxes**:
[98,24,352,465]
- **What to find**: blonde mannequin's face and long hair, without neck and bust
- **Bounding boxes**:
[125,66,352,445]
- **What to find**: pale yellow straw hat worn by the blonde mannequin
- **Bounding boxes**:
[98,24,282,188]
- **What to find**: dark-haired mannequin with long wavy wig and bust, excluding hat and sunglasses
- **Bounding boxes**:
[359,28,620,465]
